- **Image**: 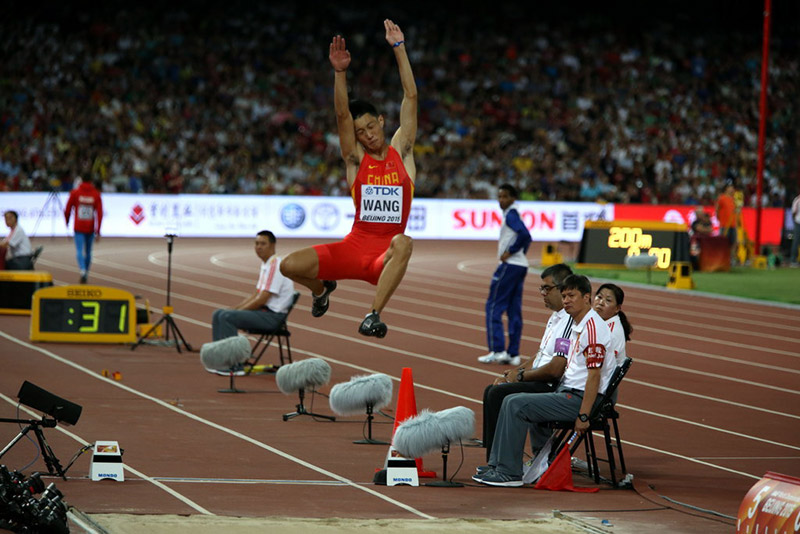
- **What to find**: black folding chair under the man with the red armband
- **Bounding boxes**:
[545,357,633,487]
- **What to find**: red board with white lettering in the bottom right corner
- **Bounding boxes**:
[736,471,800,534]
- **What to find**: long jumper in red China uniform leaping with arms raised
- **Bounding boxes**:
[281,19,417,338]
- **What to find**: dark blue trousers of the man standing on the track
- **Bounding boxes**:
[486,263,528,356]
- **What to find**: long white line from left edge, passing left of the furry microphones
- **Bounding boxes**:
[0,331,436,519]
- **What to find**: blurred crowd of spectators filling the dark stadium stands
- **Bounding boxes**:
[0,0,800,206]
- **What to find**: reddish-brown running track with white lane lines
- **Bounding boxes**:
[0,238,800,534]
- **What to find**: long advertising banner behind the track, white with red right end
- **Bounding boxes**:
[0,193,783,244]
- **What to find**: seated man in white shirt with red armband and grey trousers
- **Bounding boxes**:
[472,275,616,486]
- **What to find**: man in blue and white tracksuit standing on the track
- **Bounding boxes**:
[478,184,531,365]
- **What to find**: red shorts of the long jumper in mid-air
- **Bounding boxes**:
[314,234,394,285]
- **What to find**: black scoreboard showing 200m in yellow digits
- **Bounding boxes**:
[578,221,689,269]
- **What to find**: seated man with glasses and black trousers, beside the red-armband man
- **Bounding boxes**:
[483,263,573,461]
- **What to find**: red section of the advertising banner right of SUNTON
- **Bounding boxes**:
[614,204,783,245]
